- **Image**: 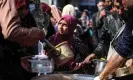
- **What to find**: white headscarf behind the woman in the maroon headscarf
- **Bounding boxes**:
[62,4,76,16]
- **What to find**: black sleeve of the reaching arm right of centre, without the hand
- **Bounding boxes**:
[93,20,111,57]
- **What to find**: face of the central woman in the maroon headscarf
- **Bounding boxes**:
[58,20,68,34]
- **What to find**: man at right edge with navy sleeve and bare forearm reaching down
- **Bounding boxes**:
[95,0,133,80]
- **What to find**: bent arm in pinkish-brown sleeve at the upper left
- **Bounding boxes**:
[0,0,45,46]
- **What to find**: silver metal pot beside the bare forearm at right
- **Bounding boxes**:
[93,59,107,75]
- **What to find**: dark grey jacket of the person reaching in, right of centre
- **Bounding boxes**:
[94,15,123,57]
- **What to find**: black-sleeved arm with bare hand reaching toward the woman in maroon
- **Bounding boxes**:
[83,20,111,64]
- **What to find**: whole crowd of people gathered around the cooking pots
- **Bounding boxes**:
[0,0,133,80]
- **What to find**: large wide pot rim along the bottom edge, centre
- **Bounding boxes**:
[31,74,94,80]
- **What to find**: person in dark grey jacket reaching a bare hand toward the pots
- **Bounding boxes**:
[83,0,124,63]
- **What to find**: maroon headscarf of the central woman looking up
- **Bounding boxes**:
[50,15,77,46]
